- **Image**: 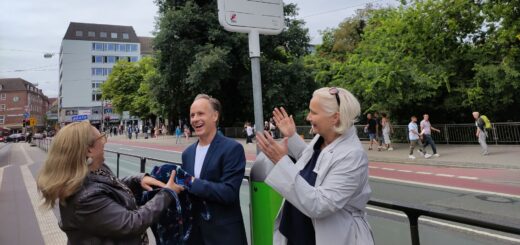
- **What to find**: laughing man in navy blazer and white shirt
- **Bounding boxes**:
[182,94,247,245]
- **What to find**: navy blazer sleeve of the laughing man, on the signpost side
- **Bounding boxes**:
[189,142,246,205]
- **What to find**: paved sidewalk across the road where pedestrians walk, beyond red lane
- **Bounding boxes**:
[109,135,520,169]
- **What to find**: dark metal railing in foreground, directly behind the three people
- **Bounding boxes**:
[91,150,520,245]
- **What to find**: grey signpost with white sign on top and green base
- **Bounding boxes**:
[218,0,284,245]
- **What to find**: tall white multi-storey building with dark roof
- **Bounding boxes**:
[58,22,141,128]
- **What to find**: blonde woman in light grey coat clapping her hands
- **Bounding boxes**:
[257,87,374,245]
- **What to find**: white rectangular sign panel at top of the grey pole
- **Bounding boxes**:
[218,0,284,35]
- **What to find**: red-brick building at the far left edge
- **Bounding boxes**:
[0,78,49,132]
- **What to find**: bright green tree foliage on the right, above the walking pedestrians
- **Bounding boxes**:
[306,0,520,122]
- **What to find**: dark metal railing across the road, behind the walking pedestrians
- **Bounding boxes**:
[224,122,520,144]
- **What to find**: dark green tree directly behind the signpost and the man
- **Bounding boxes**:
[150,0,314,125]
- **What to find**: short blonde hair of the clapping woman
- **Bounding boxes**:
[312,87,361,134]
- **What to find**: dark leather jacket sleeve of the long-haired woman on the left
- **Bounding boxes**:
[73,190,174,237]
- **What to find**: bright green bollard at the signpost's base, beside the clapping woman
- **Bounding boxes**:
[250,153,282,245]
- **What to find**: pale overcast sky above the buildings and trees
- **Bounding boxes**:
[0,0,397,97]
